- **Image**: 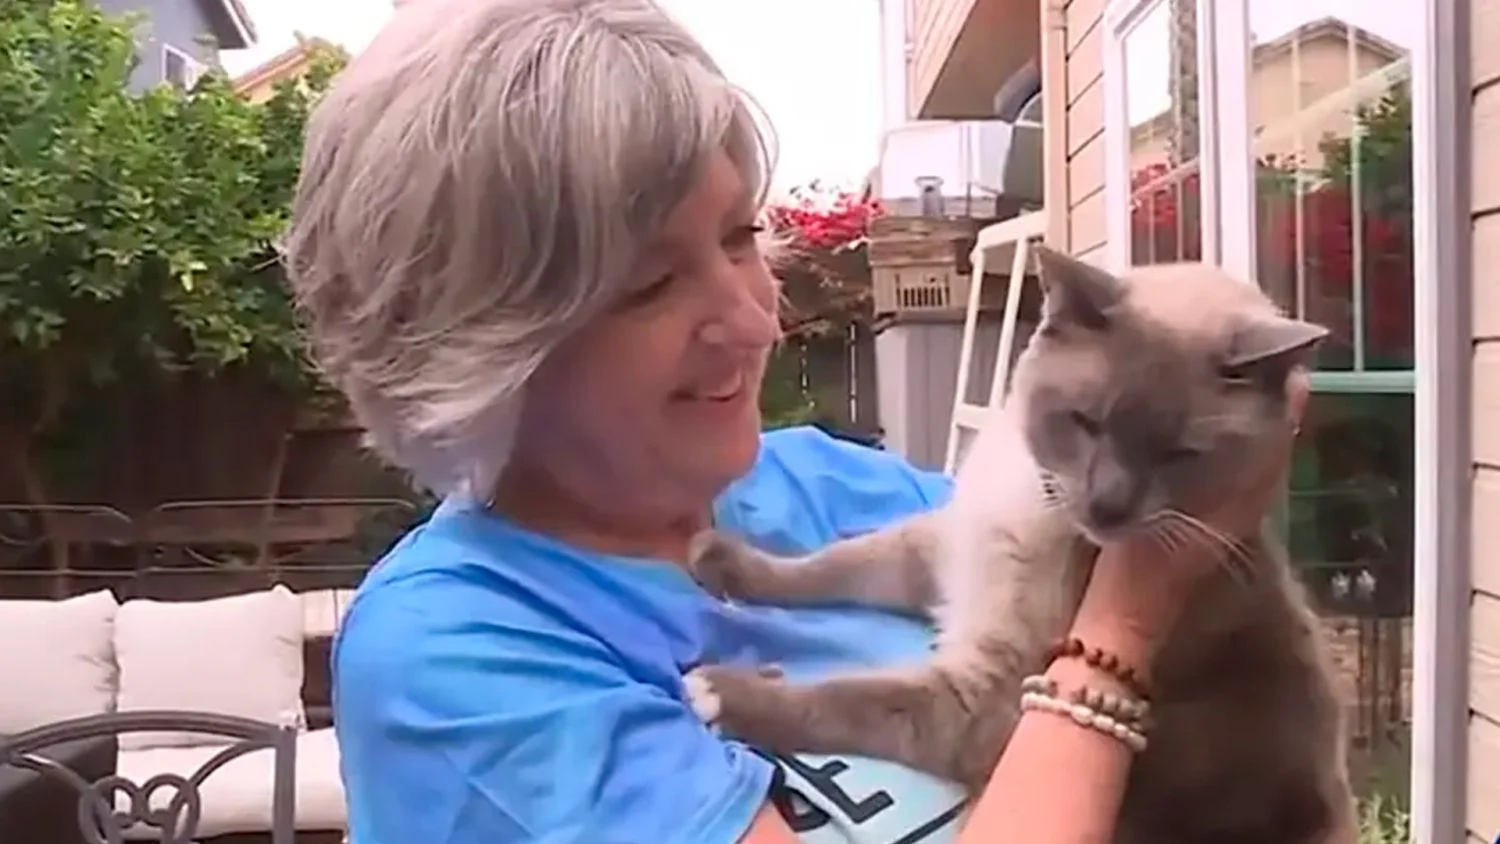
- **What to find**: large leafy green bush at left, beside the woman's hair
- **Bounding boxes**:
[0,0,338,435]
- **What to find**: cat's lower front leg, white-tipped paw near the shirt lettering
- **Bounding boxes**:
[684,666,1020,790]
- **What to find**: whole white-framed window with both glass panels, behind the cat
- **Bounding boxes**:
[1104,0,1425,787]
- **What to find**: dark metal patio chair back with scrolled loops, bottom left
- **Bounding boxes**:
[0,711,297,844]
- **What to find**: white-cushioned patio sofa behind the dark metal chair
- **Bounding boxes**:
[0,579,353,844]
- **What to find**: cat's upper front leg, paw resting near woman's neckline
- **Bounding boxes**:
[689,514,939,615]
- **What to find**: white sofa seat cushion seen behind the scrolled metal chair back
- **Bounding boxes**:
[116,727,347,841]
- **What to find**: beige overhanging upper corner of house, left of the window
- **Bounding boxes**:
[906,0,1041,120]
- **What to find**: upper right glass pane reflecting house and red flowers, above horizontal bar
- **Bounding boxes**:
[1247,6,1421,370]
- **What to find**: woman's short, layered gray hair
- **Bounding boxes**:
[285,0,770,495]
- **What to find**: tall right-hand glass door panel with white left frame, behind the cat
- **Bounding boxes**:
[1214,0,1422,802]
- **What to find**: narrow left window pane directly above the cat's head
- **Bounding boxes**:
[1125,0,1203,264]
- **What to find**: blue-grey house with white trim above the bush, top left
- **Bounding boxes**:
[96,0,257,88]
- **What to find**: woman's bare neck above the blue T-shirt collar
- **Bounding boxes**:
[491,463,713,565]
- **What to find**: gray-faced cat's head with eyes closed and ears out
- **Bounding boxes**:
[1014,249,1328,541]
